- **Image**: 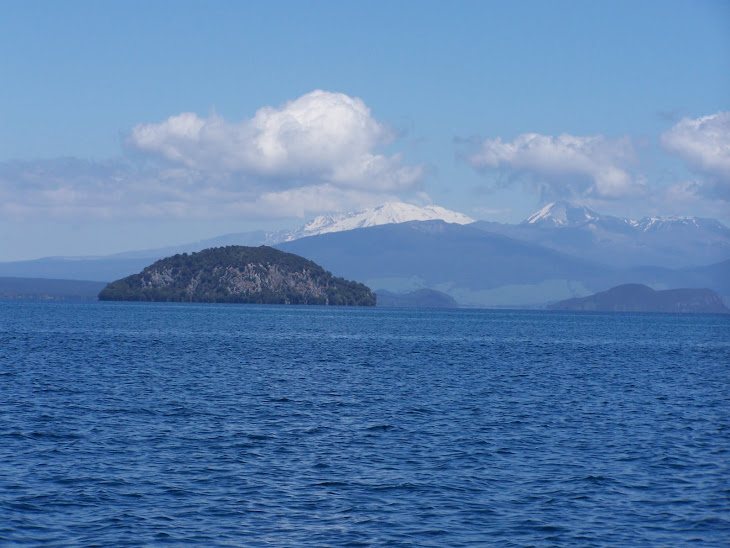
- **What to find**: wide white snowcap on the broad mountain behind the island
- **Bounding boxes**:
[277,202,474,242]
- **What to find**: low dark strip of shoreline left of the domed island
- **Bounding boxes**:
[0,277,106,301]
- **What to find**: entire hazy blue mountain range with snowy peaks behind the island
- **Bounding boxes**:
[0,202,730,306]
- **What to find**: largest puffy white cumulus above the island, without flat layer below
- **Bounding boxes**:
[127,90,423,192]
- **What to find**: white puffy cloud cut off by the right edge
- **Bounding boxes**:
[661,112,730,185]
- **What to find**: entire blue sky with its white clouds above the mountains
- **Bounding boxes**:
[0,0,730,261]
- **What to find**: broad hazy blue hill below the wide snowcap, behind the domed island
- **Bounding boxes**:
[276,221,730,306]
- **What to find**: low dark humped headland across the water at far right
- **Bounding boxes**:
[548,284,730,314]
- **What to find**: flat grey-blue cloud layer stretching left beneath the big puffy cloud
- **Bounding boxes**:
[0,159,397,221]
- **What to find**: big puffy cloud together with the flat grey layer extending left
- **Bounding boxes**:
[0,91,424,220]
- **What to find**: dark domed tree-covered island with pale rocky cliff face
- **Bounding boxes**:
[99,246,375,306]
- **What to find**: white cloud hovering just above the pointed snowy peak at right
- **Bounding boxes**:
[467,133,646,199]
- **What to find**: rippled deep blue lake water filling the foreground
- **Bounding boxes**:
[0,302,730,546]
